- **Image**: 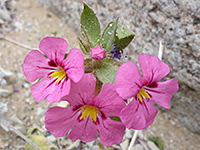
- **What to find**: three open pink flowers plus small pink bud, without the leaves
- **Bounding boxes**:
[23,37,178,146]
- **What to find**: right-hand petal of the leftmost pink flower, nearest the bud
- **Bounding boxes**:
[63,49,84,83]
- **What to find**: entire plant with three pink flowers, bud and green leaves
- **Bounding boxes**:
[23,1,179,146]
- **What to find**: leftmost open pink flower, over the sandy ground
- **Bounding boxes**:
[23,37,84,103]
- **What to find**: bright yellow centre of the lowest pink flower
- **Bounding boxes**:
[80,105,99,122]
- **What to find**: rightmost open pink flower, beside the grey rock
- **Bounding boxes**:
[115,54,179,130]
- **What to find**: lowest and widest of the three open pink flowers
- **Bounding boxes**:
[45,74,125,146]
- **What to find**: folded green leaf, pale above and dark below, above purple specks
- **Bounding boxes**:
[115,23,135,49]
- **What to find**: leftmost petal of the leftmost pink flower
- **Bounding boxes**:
[23,50,51,82]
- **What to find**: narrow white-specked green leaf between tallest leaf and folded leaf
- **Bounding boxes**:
[100,19,118,51]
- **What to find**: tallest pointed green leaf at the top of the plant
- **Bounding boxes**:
[81,4,101,48]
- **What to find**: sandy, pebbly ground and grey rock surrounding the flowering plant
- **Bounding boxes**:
[0,0,200,150]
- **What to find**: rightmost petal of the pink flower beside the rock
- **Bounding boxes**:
[147,78,179,109]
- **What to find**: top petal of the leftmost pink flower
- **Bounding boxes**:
[39,37,68,65]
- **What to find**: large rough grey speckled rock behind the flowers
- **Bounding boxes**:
[38,0,200,134]
